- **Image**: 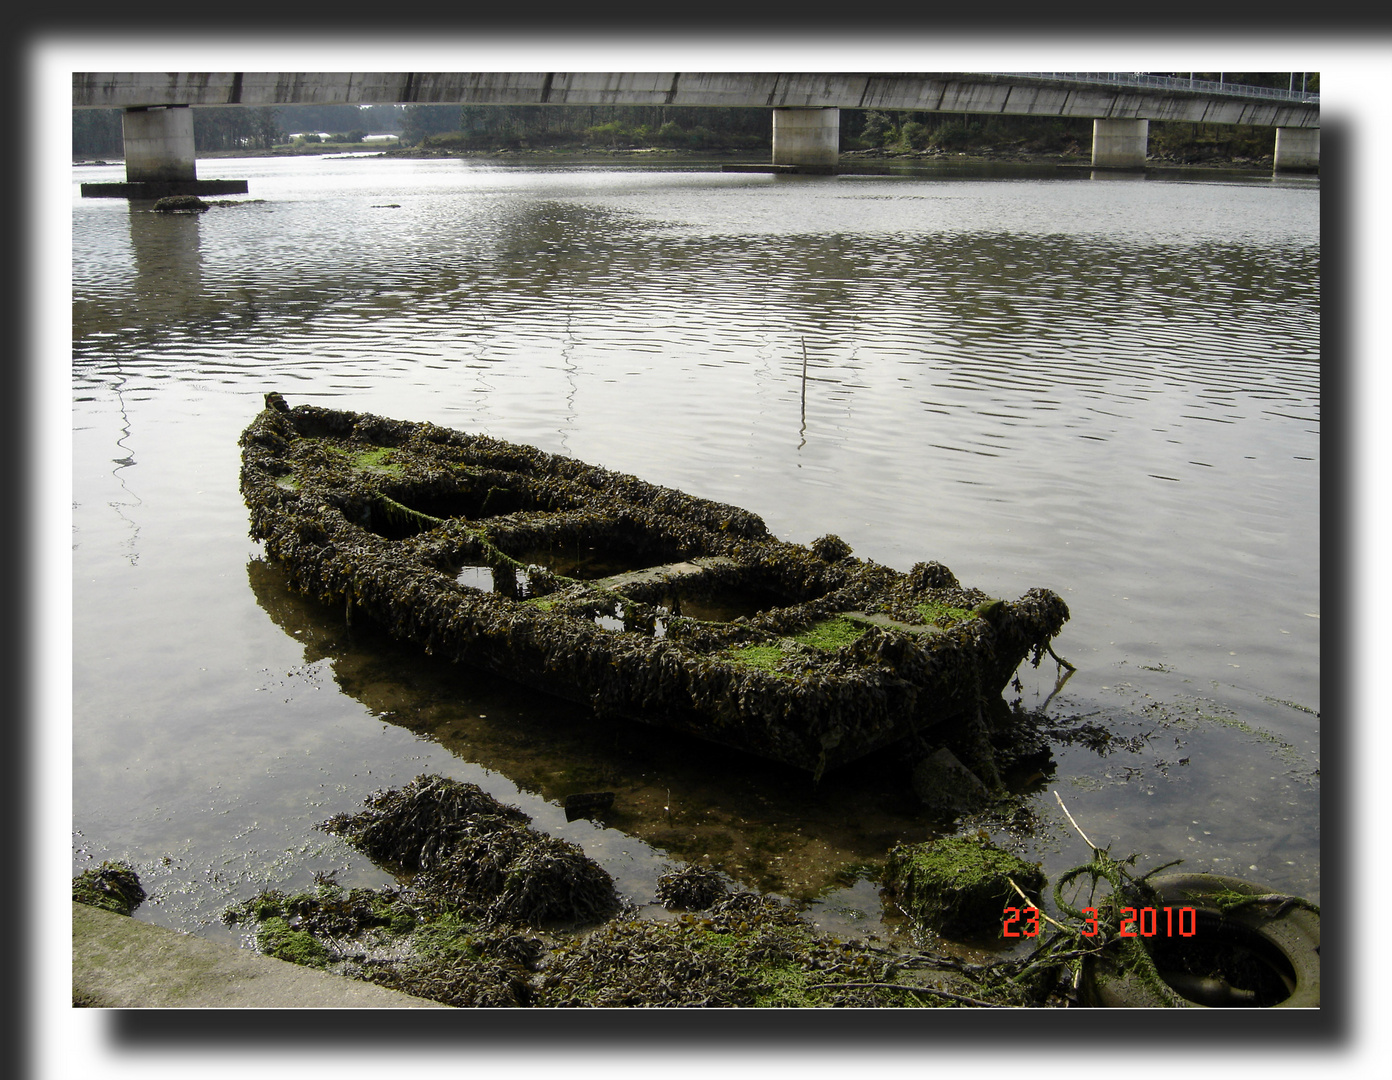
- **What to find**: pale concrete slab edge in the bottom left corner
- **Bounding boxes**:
[72,902,448,1009]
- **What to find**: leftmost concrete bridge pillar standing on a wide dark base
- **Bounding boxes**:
[82,106,246,199]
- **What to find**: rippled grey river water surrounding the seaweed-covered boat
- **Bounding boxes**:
[72,157,1320,939]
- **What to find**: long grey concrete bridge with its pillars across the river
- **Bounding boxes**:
[72,71,1320,198]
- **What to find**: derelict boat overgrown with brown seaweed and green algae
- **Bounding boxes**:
[241,394,1068,779]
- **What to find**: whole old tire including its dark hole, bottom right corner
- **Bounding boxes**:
[1079,874,1320,1009]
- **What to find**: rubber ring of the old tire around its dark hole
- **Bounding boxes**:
[1079,874,1320,1009]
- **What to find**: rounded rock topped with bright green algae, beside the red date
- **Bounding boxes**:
[885,836,1044,937]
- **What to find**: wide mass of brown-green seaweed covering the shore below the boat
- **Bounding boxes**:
[223,777,1074,1008]
